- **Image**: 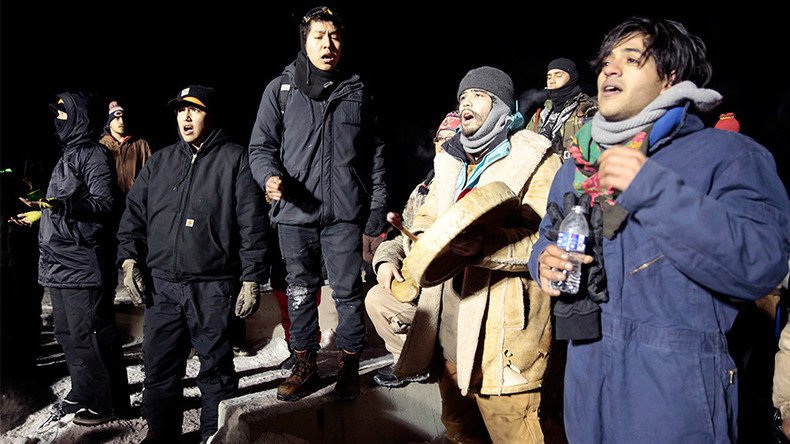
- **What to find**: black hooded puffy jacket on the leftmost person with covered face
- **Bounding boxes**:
[38,93,116,288]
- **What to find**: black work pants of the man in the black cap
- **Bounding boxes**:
[142,278,239,438]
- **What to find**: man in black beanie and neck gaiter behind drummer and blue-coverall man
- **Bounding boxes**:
[527,58,598,160]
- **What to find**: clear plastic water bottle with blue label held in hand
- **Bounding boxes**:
[551,205,590,294]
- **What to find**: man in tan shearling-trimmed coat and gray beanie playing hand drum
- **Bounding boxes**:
[402,66,561,443]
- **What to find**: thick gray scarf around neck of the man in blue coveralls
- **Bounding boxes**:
[592,80,722,147]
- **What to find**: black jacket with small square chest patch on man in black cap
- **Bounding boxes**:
[118,130,269,283]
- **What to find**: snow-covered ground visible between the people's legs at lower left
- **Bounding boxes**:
[0,286,390,444]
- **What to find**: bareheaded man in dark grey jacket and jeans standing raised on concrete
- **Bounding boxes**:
[250,7,387,401]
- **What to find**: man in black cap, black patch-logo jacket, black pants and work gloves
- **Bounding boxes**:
[118,85,269,443]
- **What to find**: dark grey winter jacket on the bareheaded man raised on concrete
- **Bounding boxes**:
[249,64,387,225]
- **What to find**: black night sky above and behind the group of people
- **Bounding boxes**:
[0,1,790,206]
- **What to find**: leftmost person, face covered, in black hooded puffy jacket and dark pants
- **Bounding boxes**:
[15,92,129,425]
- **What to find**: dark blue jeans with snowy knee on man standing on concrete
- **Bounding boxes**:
[278,222,365,352]
